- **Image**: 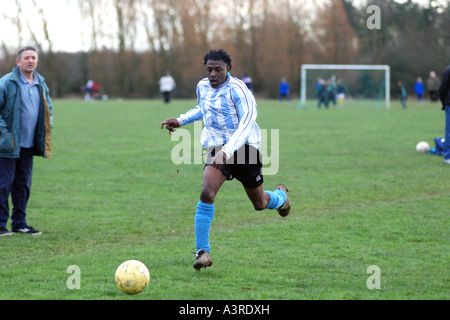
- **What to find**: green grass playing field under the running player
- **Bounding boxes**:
[0,100,450,300]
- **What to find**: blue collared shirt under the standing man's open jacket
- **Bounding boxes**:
[20,73,40,148]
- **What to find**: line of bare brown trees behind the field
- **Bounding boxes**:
[0,0,450,98]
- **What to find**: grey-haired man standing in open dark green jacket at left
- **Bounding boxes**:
[0,47,53,236]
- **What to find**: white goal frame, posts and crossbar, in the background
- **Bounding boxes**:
[298,64,391,109]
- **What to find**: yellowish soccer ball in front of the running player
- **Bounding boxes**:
[115,260,150,294]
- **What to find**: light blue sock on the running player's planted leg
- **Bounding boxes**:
[195,201,214,252]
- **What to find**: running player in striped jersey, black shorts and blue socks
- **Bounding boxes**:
[161,50,291,270]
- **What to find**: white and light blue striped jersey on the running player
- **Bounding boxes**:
[177,76,261,158]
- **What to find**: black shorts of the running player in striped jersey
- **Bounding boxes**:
[205,144,264,189]
